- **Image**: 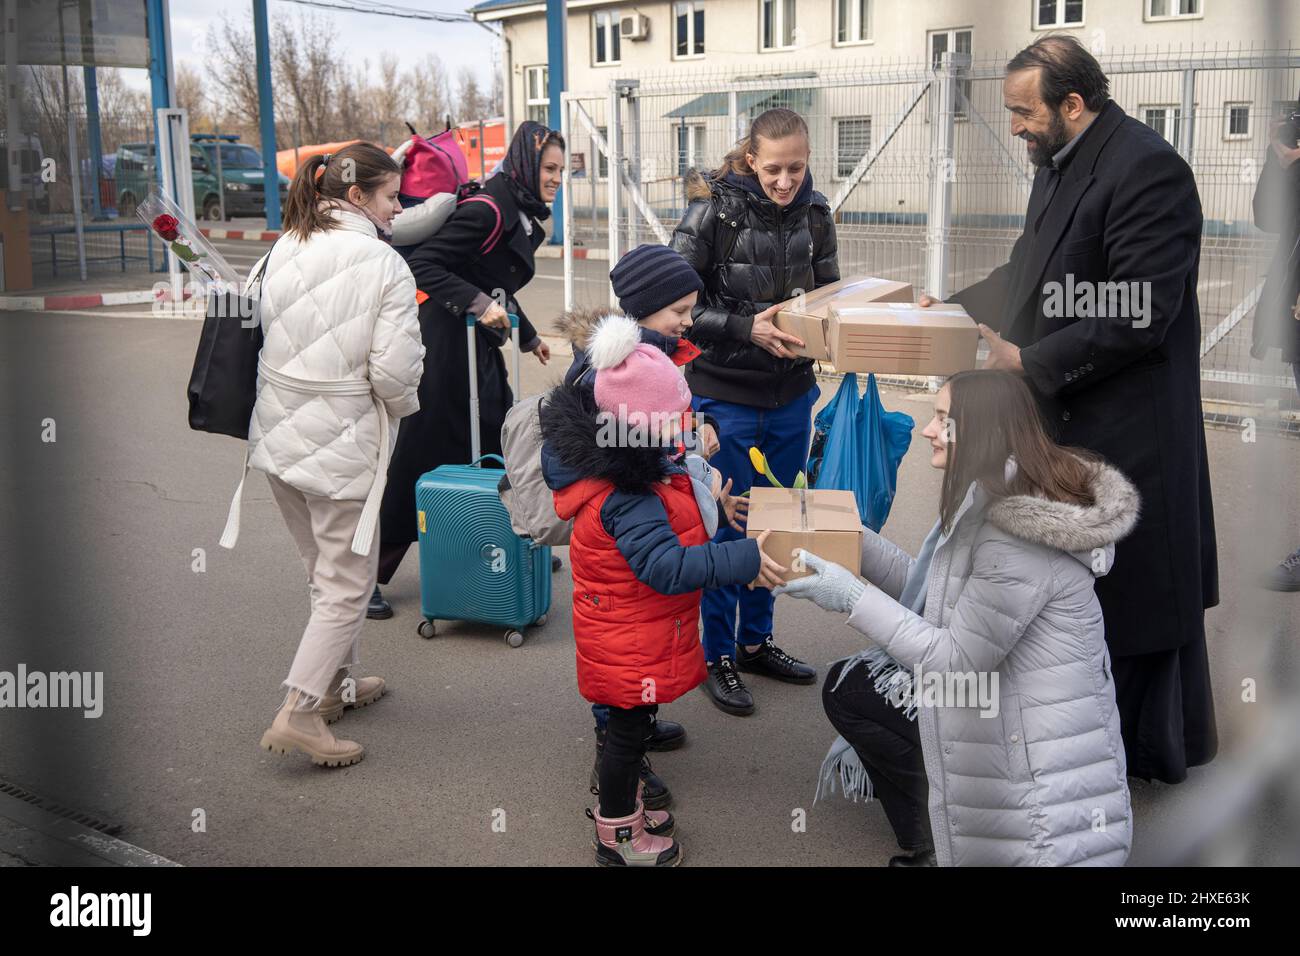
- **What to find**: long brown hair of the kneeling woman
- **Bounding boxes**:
[939,369,1099,532]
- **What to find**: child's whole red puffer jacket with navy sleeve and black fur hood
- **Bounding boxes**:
[538,385,759,708]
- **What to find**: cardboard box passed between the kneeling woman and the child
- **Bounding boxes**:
[746,488,862,580]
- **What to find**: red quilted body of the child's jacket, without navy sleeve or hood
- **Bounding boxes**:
[555,475,709,708]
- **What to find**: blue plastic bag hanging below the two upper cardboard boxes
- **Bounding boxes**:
[807,372,917,531]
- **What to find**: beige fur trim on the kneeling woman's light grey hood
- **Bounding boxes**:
[988,462,1141,566]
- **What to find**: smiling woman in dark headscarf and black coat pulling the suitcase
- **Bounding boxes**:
[368,122,564,618]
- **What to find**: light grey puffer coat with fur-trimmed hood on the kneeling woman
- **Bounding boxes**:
[849,464,1139,866]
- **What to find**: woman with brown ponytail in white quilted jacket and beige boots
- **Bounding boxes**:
[221,143,424,766]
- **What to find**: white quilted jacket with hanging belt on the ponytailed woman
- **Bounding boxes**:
[222,209,424,553]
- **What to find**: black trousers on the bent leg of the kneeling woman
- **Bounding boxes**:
[822,662,933,853]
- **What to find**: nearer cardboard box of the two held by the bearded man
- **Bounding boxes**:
[827,302,979,375]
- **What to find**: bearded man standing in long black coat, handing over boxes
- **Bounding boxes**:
[925,36,1218,783]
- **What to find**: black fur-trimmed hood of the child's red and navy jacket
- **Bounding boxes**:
[538,385,681,504]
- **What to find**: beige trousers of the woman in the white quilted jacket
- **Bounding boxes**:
[267,475,380,697]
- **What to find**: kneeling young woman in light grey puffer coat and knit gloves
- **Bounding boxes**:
[776,371,1139,866]
